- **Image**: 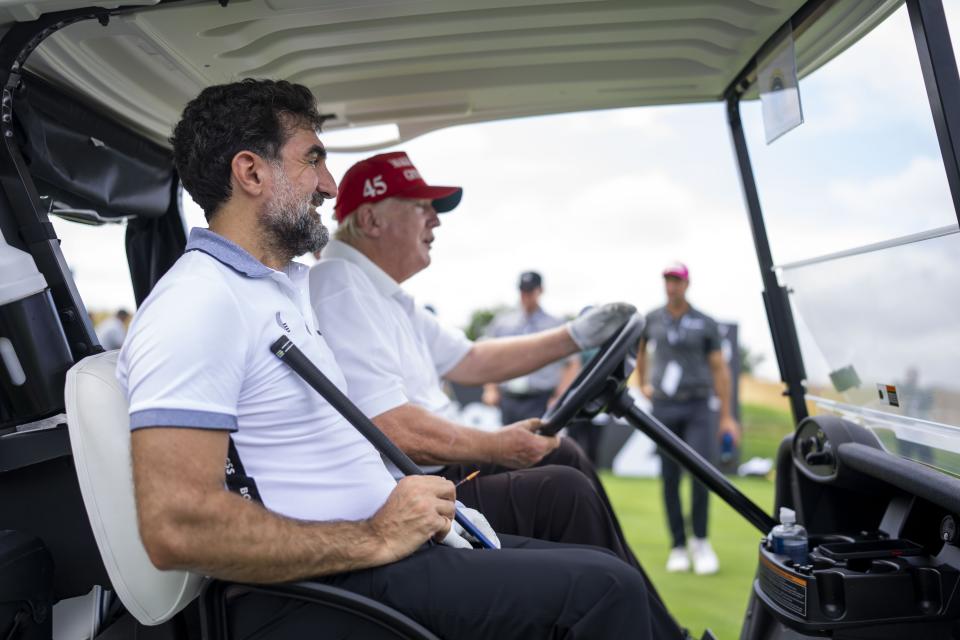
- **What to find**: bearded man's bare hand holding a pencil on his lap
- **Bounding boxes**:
[370,475,456,562]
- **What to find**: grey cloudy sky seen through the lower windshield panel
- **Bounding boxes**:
[786,233,960,389]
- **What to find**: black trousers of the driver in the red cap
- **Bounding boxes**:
[440,438,679,638]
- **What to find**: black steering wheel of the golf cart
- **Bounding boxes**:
[540,313,644,436]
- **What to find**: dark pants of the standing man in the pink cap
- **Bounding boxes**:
[653,398,717,547]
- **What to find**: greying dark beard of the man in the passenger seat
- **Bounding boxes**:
[260,168,330,262]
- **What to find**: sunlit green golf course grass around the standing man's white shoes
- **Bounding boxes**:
[603,405,792,640]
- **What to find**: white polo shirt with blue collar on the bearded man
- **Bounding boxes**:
[117,229,396,521]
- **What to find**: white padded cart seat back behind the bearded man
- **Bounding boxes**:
[65,351,205,625]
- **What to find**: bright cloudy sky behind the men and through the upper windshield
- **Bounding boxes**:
[55,3,960,378]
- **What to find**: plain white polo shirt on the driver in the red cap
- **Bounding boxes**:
[310,240,473,417]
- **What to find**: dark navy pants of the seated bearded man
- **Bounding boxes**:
[230,536,681,640]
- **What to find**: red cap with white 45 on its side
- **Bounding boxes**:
[333,151,463,222]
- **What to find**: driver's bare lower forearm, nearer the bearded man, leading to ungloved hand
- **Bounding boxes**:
[373,403,495,464]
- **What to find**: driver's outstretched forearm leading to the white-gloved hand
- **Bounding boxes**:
[445,326,579,385]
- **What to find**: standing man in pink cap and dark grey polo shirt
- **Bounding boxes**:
[637,262,740,574]
